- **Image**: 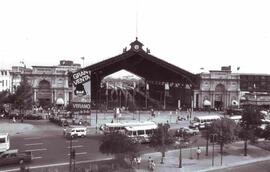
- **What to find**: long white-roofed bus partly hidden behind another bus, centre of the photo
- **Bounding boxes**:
[100,121,156,134]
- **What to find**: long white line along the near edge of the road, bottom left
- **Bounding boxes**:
[6,158,113,172]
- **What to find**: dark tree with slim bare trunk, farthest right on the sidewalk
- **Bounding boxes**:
[239,105,263,156]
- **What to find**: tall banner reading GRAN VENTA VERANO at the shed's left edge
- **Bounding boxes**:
[71,69,91,115]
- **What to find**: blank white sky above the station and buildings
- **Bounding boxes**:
[0,0,270,74]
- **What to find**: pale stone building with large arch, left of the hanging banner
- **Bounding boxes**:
[24,60,81,107]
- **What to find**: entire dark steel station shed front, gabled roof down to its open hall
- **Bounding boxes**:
[85,39,197,110]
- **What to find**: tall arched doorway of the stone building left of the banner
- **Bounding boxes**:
[37,80,52,108]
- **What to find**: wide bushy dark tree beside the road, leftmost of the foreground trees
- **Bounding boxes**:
[99,132,140,167]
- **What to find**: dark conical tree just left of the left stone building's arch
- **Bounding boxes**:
[13,76,33,111]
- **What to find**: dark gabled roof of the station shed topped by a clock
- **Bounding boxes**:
[85,40,197,85]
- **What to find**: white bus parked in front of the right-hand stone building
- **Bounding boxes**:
[189,115,221,129]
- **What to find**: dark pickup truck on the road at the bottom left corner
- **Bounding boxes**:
[0,149,32,166]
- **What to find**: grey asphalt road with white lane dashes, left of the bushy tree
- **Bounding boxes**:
[0,122,108,171]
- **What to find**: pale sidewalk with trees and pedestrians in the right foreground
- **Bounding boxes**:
[136,142,270,172]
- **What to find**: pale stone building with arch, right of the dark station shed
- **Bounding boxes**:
[194,66,240,110]
